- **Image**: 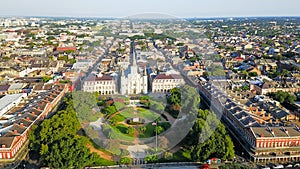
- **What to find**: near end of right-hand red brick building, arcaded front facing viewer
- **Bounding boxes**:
[250,126,300,163]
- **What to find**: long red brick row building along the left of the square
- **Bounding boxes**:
[0,84,69,160]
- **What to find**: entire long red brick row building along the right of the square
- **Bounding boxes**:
[198,82,300,163]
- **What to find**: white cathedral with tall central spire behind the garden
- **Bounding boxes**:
[120,43,148,95]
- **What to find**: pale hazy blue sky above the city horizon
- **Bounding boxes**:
[0,0,300,17]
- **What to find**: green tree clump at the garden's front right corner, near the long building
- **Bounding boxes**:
[187,110,234,161]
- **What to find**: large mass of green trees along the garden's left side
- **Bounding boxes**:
[28,94,113,168]
